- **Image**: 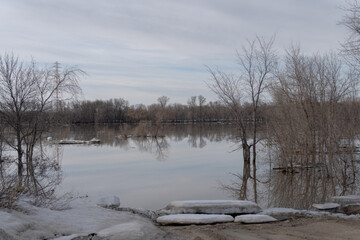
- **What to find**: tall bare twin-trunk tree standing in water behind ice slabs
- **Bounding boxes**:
[208,37,277,201]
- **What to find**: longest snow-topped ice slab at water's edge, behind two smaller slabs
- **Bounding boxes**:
[164,200,261,215]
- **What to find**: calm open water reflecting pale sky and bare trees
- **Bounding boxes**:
[49,124,360,209]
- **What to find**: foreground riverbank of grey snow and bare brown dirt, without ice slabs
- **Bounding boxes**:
[0,196,360,240]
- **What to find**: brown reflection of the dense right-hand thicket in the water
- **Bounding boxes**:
[269,143,359,208]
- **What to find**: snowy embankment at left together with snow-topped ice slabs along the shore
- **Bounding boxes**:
[0,196,360,240]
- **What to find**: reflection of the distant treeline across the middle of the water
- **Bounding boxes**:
[52,124,235,160]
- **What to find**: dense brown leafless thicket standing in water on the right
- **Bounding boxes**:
[269,47,358,194]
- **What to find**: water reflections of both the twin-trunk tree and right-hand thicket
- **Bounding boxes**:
[222,137,360,209]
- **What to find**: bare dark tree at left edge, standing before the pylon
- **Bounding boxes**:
[0,54,84,204]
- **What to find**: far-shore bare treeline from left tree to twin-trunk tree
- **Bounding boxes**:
[55,95,253,124]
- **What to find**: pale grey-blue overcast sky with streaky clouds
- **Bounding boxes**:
[0,0,347,105]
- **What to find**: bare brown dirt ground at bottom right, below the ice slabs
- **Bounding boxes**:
[160,217,360,240]
